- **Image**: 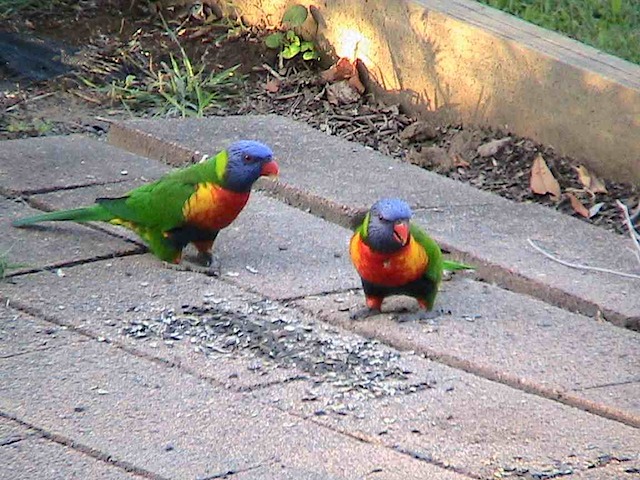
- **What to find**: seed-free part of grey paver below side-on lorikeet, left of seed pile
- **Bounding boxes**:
[0,255,301,389]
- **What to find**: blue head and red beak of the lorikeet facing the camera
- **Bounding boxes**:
[365,198,412,253]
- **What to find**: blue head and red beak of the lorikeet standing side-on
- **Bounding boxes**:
[223,140,278,192]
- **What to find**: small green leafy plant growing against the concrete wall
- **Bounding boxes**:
[264,4,319,60]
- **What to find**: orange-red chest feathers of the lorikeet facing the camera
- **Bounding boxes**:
[349,233,429,287]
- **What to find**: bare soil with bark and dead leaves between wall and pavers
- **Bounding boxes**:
[0,0,640,233]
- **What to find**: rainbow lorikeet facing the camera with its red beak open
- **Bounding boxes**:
[349,198,473,318]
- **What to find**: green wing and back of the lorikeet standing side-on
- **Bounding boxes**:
[96,151,226,232]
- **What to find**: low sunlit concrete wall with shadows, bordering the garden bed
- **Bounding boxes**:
[200,0,640,184]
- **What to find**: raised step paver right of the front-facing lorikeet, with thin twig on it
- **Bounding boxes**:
[415,204,640,325]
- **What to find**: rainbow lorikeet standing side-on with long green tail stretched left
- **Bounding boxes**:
[13,140,278,265]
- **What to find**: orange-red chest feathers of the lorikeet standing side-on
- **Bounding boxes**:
[182,183,249,230]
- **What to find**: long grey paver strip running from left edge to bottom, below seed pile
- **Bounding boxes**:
[0,322,470,480]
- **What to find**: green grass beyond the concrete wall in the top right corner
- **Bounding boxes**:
[478,0,640,64]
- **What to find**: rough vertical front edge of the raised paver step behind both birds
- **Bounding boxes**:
[108,123,640,331]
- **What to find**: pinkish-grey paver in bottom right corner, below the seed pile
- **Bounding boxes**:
[262,368,640,479]
